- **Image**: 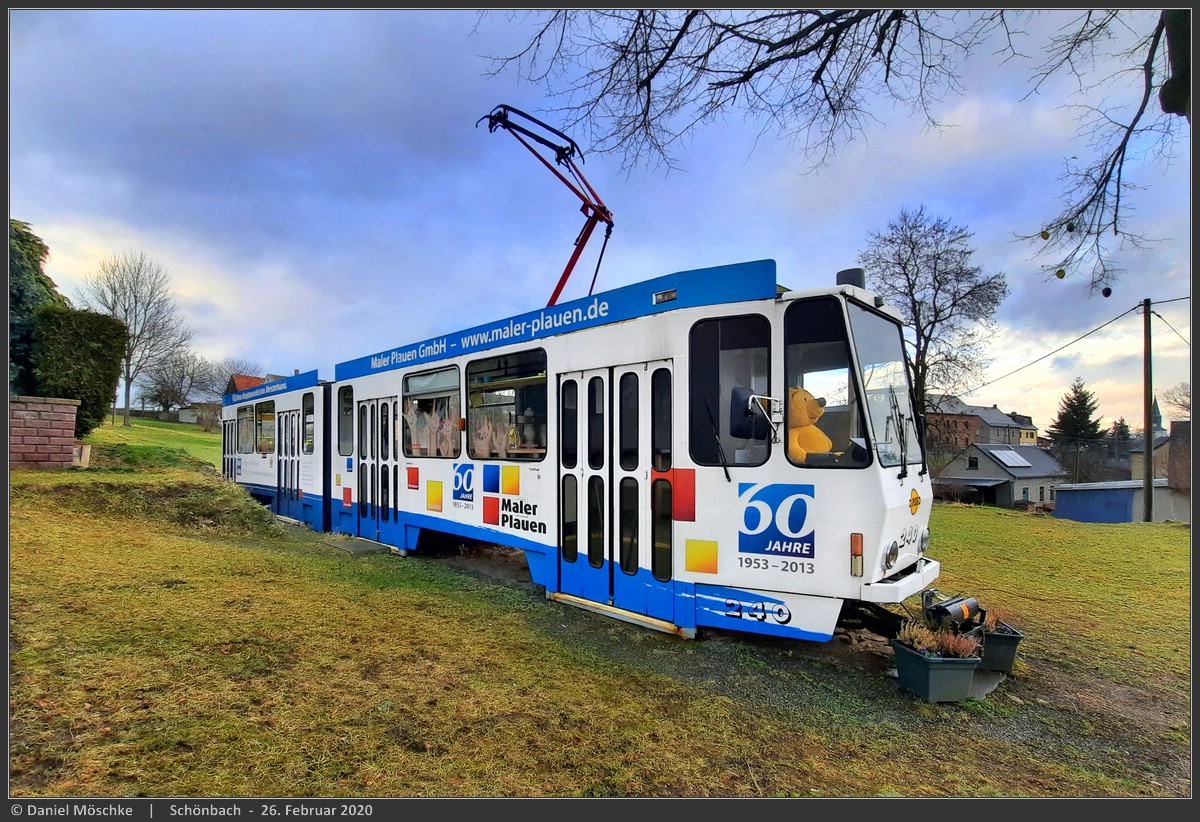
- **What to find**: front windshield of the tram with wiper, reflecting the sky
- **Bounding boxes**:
[847,302,922,466]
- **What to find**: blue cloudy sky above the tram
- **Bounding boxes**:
[8,10,1192,430]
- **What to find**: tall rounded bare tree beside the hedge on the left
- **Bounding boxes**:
[79,252,192,425]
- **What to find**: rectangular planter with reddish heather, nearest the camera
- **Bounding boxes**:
[890,619,982,702]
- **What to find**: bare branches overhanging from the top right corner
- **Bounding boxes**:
[481,8,1192,292]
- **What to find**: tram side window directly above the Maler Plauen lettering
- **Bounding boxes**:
[467,348,547,460]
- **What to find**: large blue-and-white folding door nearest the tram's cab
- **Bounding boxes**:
[558,360,673,619]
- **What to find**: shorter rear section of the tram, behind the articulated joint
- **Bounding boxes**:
[221,371,330,530]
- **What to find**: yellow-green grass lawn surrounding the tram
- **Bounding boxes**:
[10,432,1192,797]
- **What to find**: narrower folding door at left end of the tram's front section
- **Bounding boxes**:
[355,397,398,541]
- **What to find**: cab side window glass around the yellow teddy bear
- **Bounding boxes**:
[781,298,869,468]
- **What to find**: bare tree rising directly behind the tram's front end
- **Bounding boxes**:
[858,201,1008,412]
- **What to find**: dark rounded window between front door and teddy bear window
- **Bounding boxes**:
[688,314,770,466]
